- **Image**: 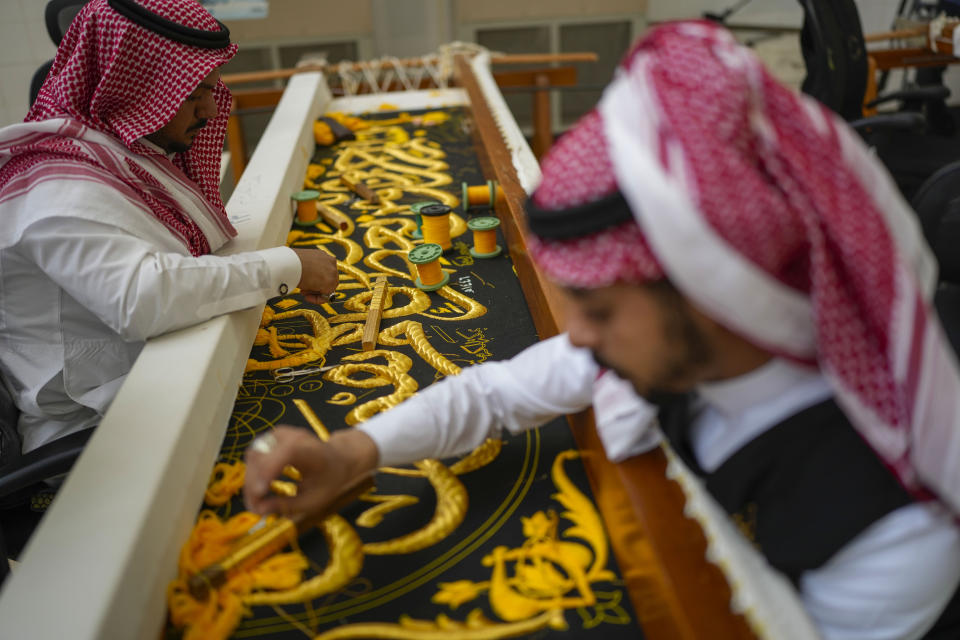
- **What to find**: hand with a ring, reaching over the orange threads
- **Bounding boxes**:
[243,426,378,515]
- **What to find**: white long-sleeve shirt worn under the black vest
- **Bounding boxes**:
[359,335,960,640]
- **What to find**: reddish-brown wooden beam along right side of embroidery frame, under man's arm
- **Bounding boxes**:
[455,57,756,640]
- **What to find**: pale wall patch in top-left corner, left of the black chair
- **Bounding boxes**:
[0,0,57,126]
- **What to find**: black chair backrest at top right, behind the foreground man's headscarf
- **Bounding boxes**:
[800,0,868,120]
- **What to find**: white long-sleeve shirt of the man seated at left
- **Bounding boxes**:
[0,181,301,451]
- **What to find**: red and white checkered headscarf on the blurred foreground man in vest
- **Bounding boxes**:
[533,22,960,513]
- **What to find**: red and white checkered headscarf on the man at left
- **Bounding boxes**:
[0,0,237,255]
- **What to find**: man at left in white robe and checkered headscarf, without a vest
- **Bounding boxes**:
[0,0,337,462]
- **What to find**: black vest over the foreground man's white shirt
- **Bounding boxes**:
[660,396,960,640]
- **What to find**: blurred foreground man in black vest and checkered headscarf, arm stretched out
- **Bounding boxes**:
[245,23,960,639]
